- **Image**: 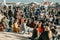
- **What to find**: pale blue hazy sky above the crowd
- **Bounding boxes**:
[0,0,60,3]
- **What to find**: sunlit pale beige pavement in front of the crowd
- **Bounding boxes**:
[0,32,29,40]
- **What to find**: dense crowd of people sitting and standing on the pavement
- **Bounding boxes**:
[0,6,58,40]
